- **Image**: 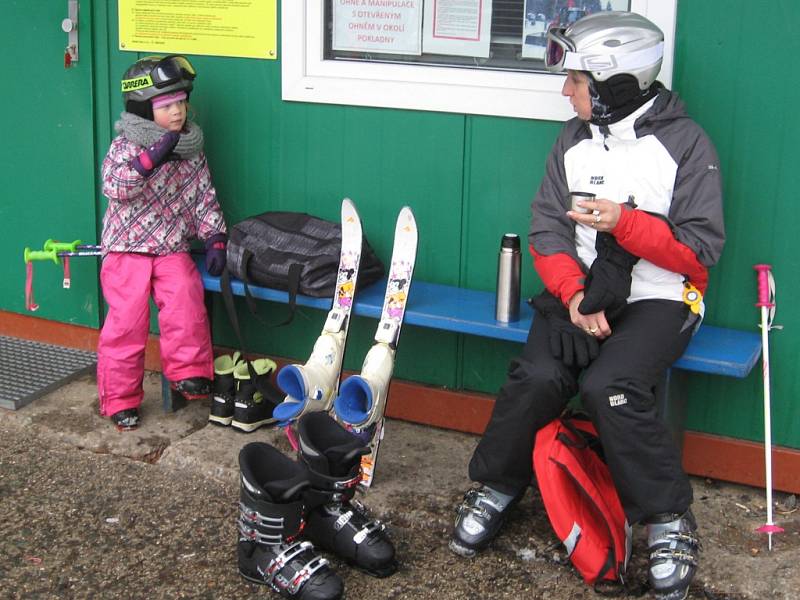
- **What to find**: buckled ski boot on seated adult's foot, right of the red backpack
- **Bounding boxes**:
[646,510,700,600]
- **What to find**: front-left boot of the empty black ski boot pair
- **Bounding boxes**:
[237,442,344,600]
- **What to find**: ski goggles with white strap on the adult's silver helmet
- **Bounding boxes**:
[544,27,664,73]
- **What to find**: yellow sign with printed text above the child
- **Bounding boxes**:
[118,0,278,59]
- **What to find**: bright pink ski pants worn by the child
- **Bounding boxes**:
[97,252,214,415]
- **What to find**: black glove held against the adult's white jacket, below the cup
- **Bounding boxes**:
[578,232,639,318]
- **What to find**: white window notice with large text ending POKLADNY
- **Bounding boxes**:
[332,0,422,55]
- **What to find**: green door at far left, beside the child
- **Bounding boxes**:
[0,0,99,327]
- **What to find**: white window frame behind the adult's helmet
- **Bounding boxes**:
[281,0,678,121]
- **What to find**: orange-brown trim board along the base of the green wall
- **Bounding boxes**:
[6,311,800,494]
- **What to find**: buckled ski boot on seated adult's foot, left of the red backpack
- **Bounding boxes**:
[450,485,525,558]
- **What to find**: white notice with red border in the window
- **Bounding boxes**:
[423,0,492,58]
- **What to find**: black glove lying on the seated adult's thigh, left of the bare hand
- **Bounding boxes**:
[530,290,600,368]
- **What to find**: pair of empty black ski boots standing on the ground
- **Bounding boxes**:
[238,412,397,600]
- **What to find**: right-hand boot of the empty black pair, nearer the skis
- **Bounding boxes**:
[297,412,397,577]
